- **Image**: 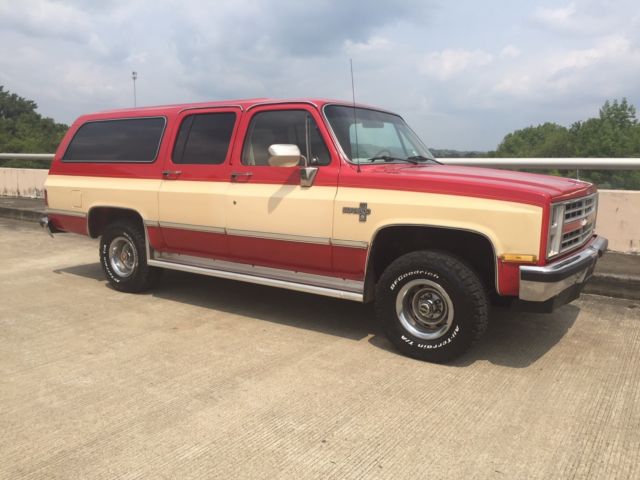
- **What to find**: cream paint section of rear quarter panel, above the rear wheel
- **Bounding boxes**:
[45,175,161,221]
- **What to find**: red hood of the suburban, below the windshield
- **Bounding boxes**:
[350,164,596,205]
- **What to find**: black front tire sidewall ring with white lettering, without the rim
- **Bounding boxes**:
[377,261,474,361]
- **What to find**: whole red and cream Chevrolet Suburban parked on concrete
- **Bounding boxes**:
[41,99,607,361]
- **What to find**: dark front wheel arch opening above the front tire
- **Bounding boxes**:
[364,224,498,302]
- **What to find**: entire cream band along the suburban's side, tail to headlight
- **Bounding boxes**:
[45,175,542,255]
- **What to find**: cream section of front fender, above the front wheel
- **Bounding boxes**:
[333,188,542,256]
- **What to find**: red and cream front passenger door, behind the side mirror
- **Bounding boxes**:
[227,104,339,275]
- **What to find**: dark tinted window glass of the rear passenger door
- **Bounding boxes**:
[173,112,236,164]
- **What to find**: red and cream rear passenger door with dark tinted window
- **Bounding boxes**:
[158,108,240,258]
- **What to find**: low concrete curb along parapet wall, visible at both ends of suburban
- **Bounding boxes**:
[0,205,640,300]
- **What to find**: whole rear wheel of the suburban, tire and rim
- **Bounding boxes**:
[100,220,162,293]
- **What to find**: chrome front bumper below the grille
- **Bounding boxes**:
[519,236,609,302]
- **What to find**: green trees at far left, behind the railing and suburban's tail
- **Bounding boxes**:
[0,85,69,168]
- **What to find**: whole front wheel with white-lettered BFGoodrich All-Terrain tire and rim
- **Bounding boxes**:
[376,251,488,362]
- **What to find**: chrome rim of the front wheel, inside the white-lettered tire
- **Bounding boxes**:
[396,279,453,340]
